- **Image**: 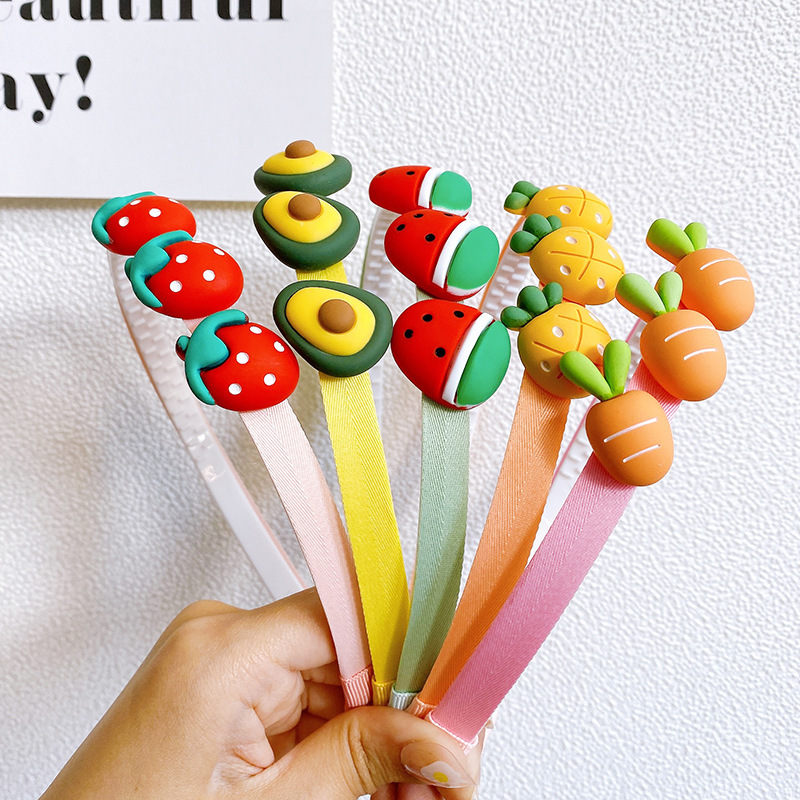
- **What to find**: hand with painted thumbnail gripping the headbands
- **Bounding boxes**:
[42,589,477,800]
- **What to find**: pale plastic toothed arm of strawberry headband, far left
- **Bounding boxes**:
[108,253,305,599]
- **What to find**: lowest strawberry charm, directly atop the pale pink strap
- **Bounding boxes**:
[176,309,300,412]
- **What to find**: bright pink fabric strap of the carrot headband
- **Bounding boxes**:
[428,364,680,749]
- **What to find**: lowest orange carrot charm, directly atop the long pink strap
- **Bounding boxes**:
[561,339,673,486]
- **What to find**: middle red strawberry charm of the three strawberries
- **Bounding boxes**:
[125,231,244,319]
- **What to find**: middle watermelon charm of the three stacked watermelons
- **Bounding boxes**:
[384,209,500,300]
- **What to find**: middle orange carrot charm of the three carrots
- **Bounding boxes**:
[616,272,727,400]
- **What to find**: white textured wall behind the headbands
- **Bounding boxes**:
[0,0,800,800]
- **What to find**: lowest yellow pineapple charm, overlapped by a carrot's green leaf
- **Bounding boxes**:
[500,283,611,399]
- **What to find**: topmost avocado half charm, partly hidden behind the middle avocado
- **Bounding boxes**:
[253,139,353,195]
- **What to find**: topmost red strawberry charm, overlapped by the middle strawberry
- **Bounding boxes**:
[92,192,197,256]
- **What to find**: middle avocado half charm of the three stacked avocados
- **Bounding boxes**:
[253,191,361,270]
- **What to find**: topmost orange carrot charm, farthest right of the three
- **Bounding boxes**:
[647,219,756,331]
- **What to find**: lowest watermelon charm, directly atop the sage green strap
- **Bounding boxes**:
[392,300,511,409]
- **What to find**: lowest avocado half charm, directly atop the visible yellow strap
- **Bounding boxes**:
[272,281,392,378]
